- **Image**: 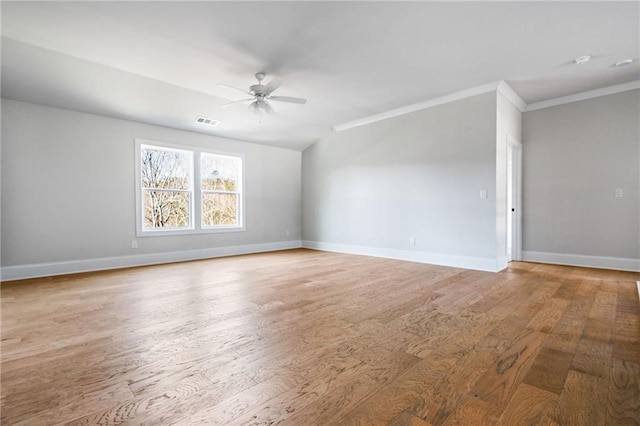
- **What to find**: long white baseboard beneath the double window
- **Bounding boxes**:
[0,240,302,281]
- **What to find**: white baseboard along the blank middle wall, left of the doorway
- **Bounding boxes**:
[302,240,501,272]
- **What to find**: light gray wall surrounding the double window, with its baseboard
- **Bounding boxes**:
[1,100,301,279]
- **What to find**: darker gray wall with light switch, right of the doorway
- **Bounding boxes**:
[523,90,640,259]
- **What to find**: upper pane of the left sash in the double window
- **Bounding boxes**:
[140,145,191,189]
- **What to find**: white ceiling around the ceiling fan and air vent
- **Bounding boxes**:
[1,1,640,150]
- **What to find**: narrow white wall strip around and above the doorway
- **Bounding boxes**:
[496,92,522,269]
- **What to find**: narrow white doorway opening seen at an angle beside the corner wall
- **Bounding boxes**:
[505,136,522,262]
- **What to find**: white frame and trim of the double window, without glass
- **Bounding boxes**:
[134,138,245,237]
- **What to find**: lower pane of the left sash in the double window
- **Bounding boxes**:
[144,189,190,229]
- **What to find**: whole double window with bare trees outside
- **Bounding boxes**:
[136,139,244,236]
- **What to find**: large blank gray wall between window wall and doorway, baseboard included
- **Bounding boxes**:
[302,92,497,270]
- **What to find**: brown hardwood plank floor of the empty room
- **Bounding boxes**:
[1,249,640,425]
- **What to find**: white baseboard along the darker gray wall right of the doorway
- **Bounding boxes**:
[522,251,640,272]
